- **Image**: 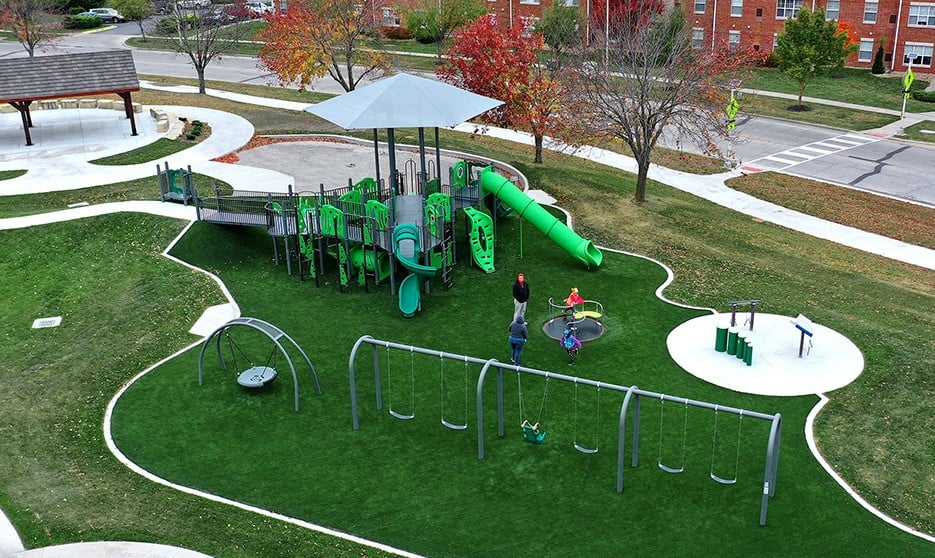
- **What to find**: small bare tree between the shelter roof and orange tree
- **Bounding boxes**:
[156,2,250,93]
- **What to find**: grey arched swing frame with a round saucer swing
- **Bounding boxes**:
[198,317,321,411]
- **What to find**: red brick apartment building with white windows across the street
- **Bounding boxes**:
[274,0,935,73]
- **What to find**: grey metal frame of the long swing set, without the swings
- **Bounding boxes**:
[348,335,782,525]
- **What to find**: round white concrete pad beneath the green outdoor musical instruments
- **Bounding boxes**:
[666,313,864,396]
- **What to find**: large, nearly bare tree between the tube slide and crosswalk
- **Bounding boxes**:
[572,6,747,202]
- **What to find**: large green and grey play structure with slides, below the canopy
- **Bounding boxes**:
[166,155,603,317]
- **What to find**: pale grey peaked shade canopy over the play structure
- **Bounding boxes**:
[305,74,503,130]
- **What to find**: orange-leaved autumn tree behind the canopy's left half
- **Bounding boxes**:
[258,0,389,91]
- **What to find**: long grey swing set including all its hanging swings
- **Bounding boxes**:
[348,335,782,525]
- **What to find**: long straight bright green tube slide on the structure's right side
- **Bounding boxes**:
[480,167,604,267]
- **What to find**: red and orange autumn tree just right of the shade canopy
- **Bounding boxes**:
[437,16,573,163]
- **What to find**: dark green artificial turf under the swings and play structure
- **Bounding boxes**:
[108,205,927,556]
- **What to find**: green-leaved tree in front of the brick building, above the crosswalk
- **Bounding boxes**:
[775,6,857,110]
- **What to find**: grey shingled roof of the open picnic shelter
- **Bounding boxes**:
[0,50,140,103]
